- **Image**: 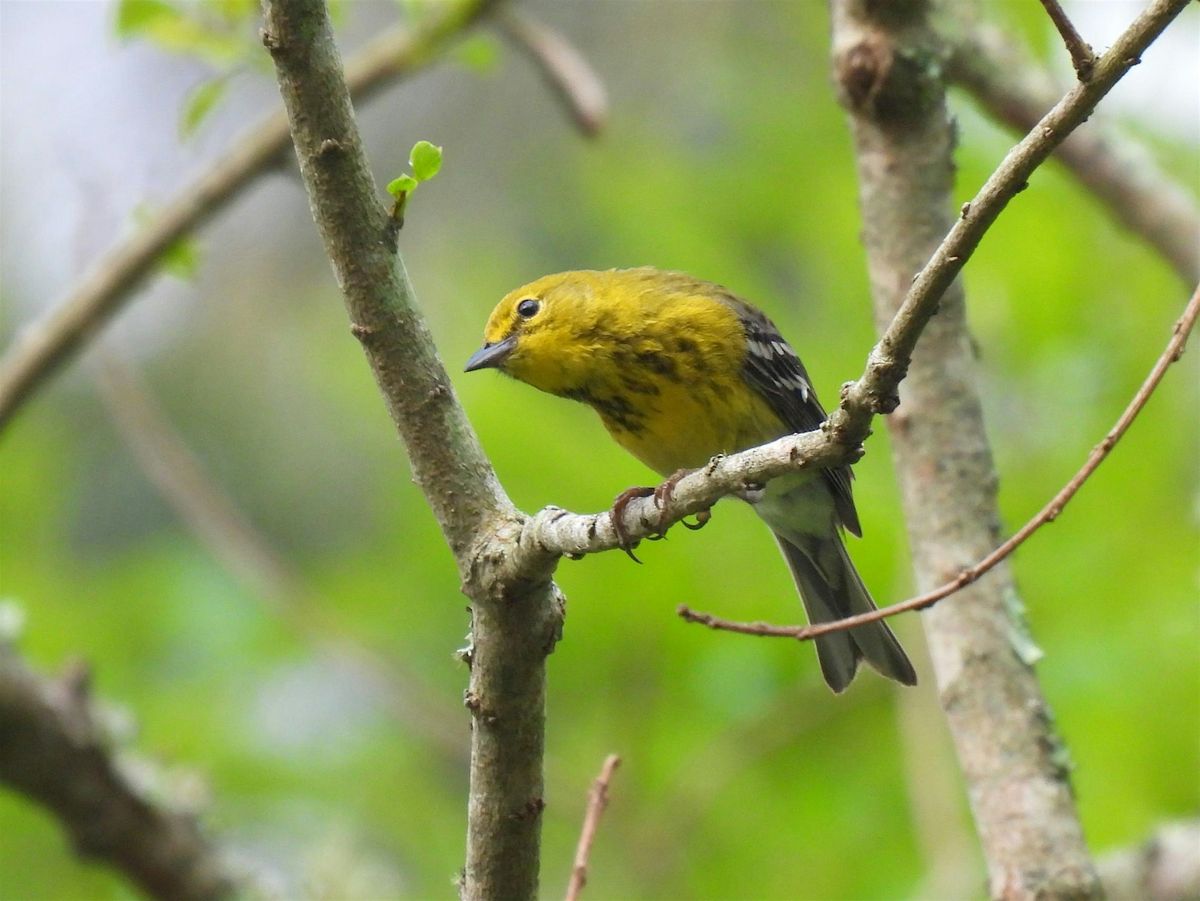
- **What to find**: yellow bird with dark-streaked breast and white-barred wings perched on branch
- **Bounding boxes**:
[466,268,917,692]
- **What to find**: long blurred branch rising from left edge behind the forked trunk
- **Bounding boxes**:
[0,0,496,431]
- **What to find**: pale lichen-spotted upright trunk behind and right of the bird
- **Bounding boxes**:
[834,0,1099,899]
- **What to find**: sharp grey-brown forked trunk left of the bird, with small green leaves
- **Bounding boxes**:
[263,0,562,901]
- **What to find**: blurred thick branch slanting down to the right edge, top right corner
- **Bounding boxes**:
[940,0,1200,286]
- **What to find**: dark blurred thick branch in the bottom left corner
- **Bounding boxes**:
[0,642,235,901]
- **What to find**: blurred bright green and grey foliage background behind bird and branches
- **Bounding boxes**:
[0,0,1200,899]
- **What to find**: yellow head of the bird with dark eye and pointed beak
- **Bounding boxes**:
[466,270,632,395]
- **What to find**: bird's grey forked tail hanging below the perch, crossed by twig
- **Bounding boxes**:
[775,531,917,692]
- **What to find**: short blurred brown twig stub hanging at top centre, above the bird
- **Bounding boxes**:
[496,7,608,138]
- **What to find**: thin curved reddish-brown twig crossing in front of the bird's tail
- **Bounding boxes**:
[676,281,1200,642]
